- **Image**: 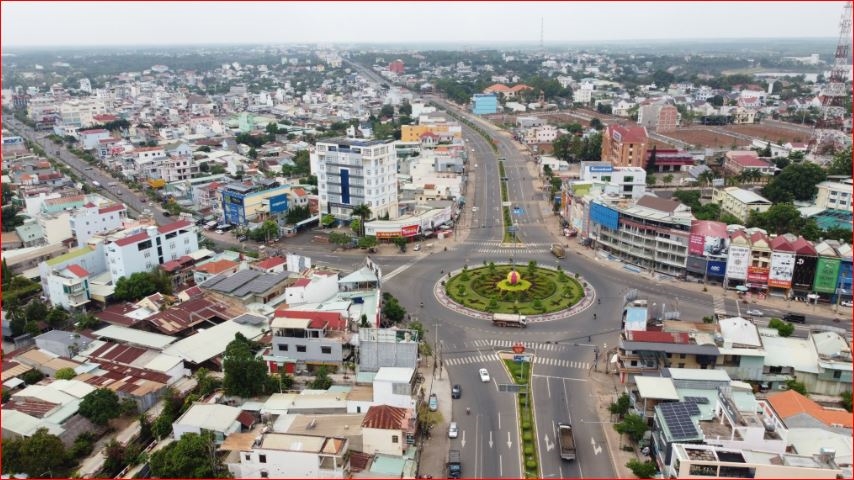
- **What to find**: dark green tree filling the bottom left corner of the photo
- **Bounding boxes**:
[2,428,68,478]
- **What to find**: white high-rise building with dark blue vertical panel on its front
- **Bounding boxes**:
[311,138,398,219]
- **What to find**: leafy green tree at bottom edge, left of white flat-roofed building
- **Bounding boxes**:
[149,432,221,478]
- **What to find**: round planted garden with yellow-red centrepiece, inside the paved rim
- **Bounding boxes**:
[444,261,584,315]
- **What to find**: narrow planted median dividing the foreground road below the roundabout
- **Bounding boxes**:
[498,347,540,478]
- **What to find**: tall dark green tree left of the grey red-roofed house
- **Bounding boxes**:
[222,333,267,398]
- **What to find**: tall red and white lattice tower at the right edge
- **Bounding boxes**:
[816,2,852,148]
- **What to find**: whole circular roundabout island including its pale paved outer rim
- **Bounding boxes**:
[433,261,596,323]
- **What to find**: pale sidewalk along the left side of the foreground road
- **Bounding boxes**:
[416,357,453,478]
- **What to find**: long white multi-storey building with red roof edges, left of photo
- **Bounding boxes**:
[104,220,199,280]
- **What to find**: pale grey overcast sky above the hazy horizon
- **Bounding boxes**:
[0,1,844,48]
